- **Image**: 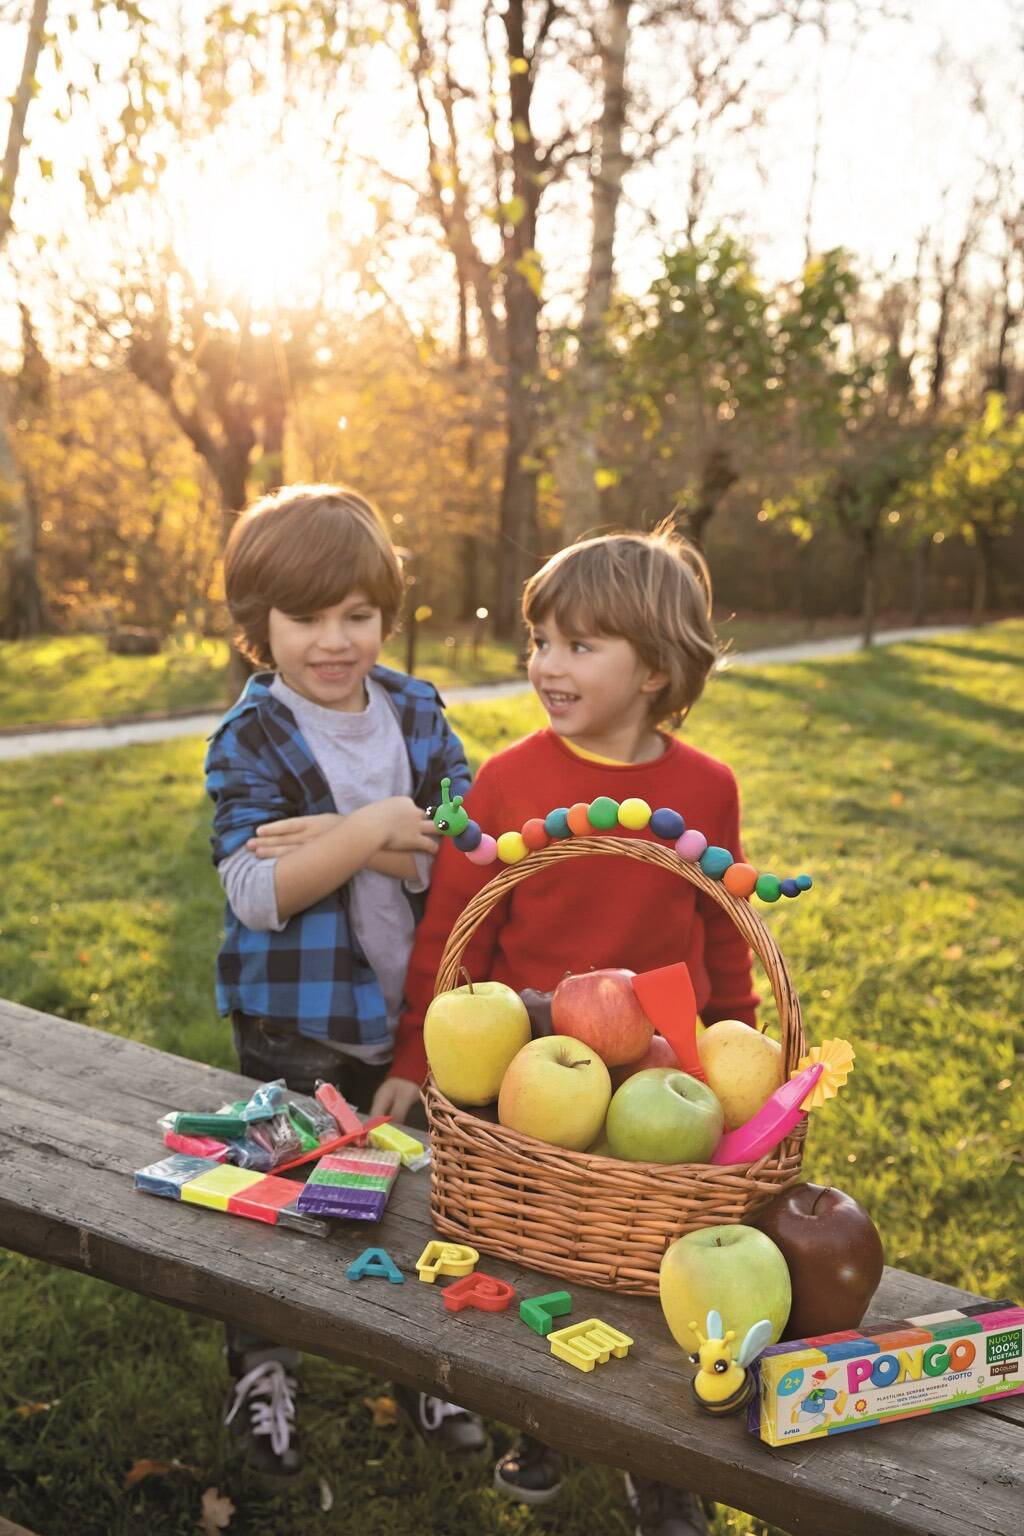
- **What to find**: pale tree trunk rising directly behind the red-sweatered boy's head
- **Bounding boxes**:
[556,0,631,544]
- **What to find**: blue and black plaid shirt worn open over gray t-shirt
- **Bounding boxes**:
[206,667,470,1044]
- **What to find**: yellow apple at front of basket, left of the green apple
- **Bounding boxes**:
[497,1035,611,1152]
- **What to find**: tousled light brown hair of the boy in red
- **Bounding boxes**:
[522,521,718,725]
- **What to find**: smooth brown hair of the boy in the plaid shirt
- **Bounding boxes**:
[224,485,404,667]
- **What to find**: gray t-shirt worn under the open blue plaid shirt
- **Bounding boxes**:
[218,677,433,1063]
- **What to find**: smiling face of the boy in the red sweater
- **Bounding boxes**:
[530,616,665,756]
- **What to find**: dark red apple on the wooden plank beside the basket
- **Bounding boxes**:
[751,1184,886,1339]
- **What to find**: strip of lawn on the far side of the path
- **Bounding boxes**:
[0,616,884,728]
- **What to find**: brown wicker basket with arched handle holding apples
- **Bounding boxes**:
[425,836,806,1295]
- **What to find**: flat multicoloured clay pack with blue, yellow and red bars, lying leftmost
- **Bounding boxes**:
[135,1152,329,1236]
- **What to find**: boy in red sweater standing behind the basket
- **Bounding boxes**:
[373,530,757,1536]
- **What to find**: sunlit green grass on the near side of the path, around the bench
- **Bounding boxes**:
[0,624,1024,1536]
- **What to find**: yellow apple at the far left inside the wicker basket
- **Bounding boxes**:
[424,982,530,1107]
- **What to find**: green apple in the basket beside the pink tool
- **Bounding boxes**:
[606,1066,722,1163]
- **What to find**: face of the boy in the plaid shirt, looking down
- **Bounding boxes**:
[269,591,384,713]
